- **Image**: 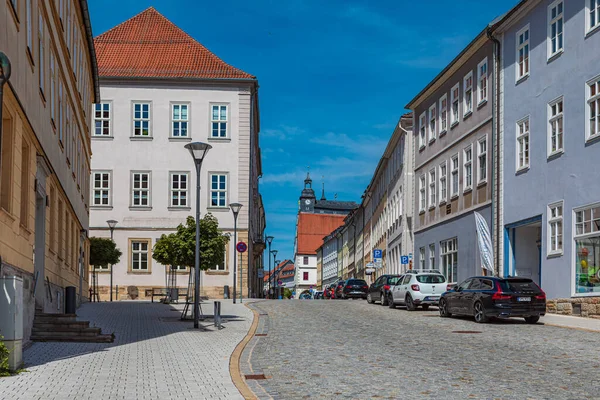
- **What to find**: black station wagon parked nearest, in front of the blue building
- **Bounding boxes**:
[439,276,546,324]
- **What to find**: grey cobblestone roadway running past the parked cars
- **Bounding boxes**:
[242,300,600,399]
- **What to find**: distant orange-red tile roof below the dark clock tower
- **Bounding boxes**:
[297,213,346,254]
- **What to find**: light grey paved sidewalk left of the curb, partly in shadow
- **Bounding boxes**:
[0,300,253,400]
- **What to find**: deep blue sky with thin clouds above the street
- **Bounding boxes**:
[89,0,517,260]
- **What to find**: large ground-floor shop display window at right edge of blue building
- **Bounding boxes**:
[574,204,600,293]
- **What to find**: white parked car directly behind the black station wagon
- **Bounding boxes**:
[388,270,448,311]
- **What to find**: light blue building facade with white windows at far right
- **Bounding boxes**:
[495,0,600,299]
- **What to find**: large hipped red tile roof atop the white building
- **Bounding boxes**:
[94,7,255,79]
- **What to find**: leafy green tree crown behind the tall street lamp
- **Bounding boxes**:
[152,213,229,271]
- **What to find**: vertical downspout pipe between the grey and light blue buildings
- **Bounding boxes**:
[486,27,502,276]
